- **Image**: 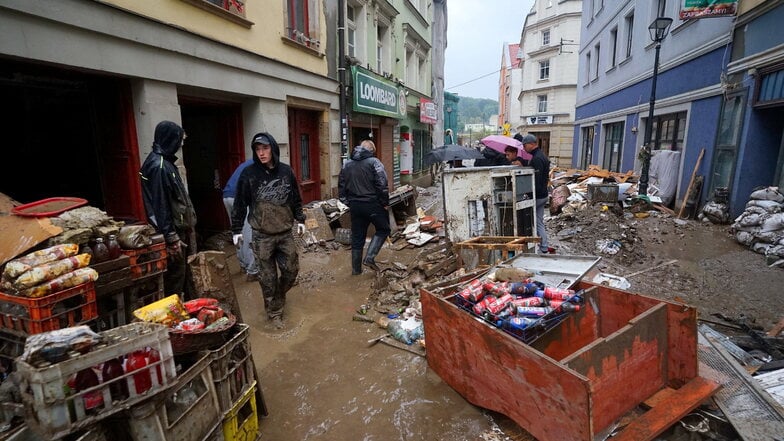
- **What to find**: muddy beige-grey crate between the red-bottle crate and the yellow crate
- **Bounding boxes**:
[125,348,223,441]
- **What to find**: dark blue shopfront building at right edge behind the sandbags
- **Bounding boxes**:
[720,0,784,218]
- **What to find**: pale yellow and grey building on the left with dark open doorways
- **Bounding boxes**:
[0,0,339,241]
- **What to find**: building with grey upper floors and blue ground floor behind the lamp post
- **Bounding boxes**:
[572,0,733,210]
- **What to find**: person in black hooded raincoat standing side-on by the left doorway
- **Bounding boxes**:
[139,121,196,298]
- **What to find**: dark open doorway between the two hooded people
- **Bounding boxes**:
[179,97,245,240]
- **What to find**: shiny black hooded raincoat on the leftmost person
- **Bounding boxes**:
[139,121,196,243]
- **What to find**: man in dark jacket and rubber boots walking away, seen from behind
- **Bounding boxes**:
[338,140,390,275]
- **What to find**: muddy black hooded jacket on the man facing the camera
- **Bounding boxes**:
[231,132,305,234]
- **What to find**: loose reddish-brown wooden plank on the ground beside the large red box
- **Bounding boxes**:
[613,377,719,441]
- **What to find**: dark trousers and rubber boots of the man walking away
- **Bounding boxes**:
[349,202,390,274]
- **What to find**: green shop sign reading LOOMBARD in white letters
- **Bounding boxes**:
[351,66,406,118]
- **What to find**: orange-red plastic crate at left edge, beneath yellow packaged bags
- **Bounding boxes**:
[0,282,98,335]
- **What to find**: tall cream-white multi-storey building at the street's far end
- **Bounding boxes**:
[511,0,582,166]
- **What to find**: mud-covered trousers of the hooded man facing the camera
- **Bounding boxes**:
[253,231,299,319]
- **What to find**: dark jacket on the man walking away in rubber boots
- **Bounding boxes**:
[338,146,389,207]
